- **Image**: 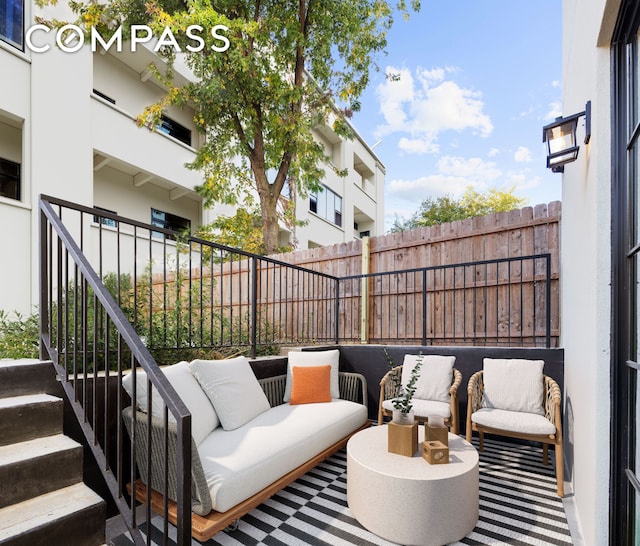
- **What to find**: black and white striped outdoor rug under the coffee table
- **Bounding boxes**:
[113,434,572,546]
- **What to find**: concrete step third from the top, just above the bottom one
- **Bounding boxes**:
[0,434,83,508]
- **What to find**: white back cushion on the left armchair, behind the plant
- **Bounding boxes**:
[402,355,456,403]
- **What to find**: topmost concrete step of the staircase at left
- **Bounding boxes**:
[0,358,56,398]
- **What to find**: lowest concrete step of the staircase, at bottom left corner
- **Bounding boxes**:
[0,483,106,546]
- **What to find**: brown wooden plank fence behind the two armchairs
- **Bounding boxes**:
[275,201,561,347]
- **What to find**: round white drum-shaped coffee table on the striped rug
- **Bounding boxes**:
[347,425,479,546]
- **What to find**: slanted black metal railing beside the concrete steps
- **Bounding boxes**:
[40,198,191,545]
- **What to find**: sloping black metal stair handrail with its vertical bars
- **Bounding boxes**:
[39,196,191,545]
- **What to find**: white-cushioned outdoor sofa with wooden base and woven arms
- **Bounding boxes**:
[123,350,370,542]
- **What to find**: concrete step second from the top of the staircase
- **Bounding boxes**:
[0,394,64,446]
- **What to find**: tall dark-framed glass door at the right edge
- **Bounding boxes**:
[609,0,640,546]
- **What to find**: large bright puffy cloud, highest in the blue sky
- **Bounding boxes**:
[376,67,493,154]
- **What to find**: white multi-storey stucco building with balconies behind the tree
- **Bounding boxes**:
[0,13,385,314]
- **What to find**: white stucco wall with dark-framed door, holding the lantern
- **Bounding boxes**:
[558,0,640,546]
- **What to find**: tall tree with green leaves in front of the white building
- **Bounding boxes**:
[40,0,420,253]
